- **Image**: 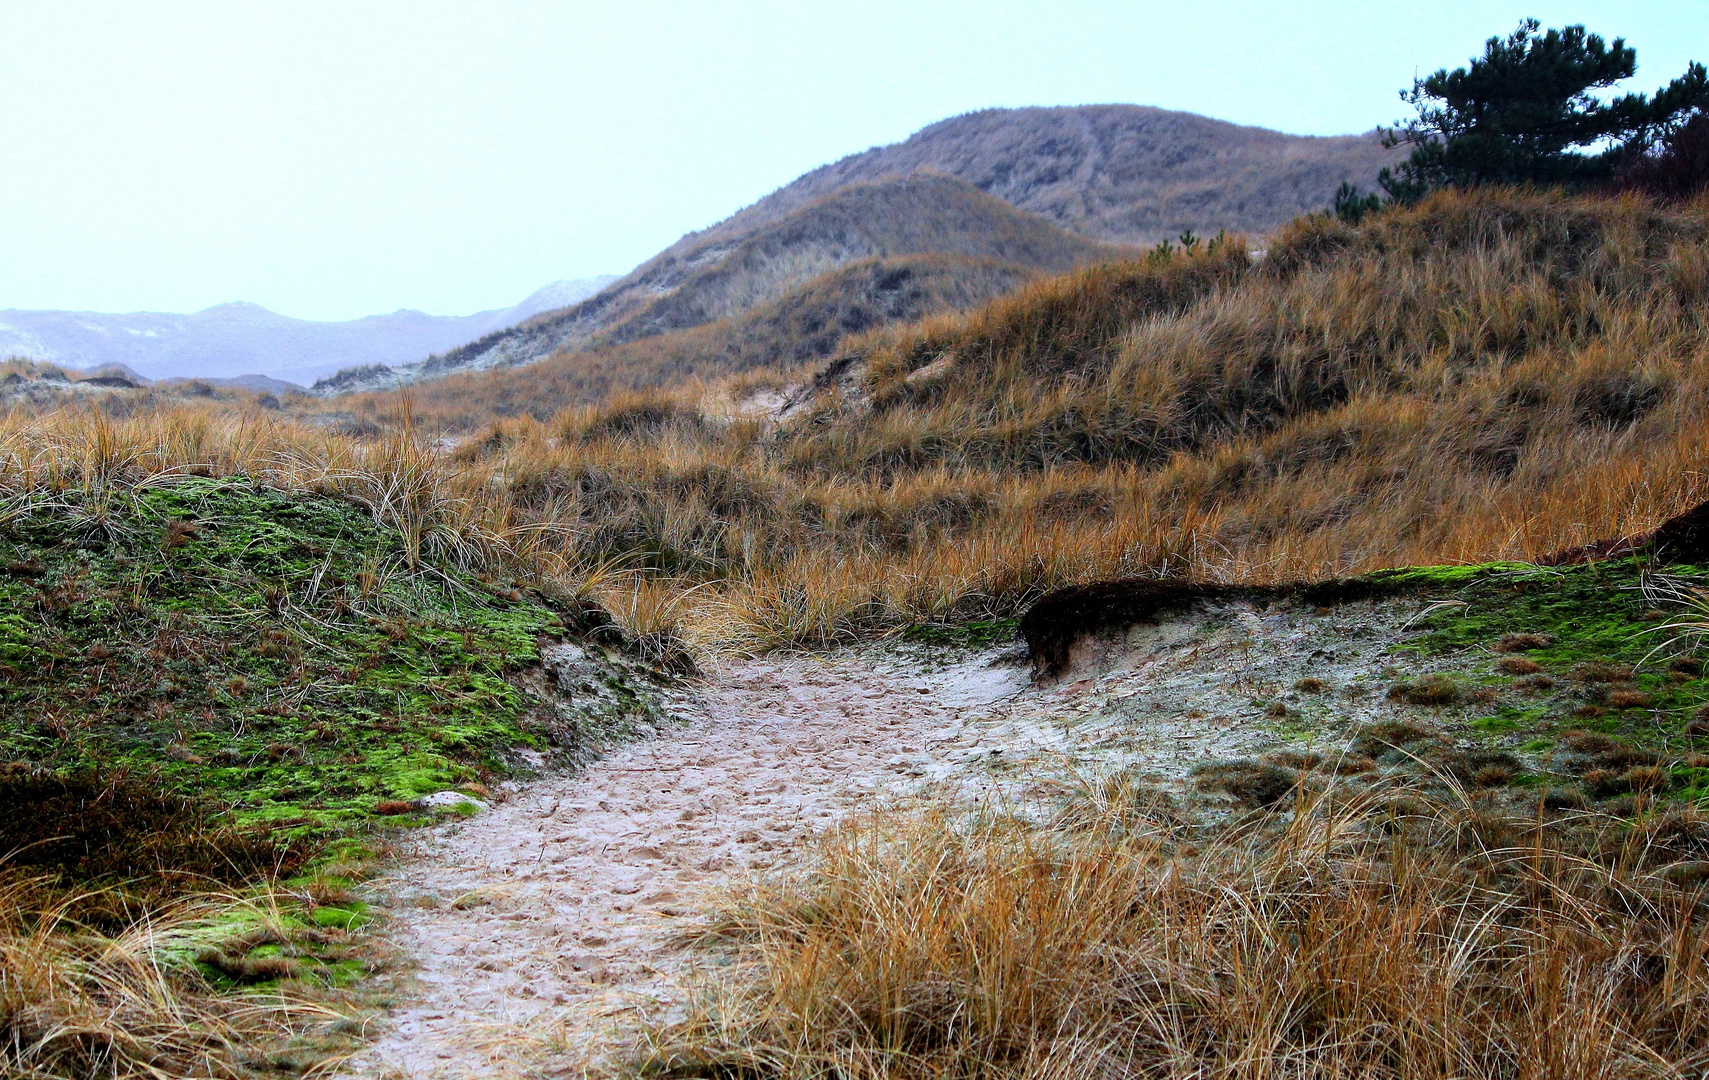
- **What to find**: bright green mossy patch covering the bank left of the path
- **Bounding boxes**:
[0,477,643,834]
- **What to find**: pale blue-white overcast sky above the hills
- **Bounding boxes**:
[0,0,1709,320]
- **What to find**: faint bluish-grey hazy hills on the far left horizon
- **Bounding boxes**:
[0,277,615,386]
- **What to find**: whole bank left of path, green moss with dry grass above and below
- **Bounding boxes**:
[0,408,680,1078]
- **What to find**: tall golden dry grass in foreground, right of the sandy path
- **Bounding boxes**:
[653,784,1709,1080]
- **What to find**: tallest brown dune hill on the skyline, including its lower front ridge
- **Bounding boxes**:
[316,104,1395,395]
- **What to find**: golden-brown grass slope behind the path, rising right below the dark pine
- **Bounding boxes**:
[20,191,1709,649]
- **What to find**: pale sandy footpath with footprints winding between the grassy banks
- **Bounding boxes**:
[354,651,1025,1080]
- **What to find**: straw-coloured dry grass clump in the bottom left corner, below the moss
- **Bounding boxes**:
[0,865,342,1080]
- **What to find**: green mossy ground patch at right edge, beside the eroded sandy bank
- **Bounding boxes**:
[1376,559,1709,801]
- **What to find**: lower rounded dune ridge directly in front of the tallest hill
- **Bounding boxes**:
[314,174,1125,395]
